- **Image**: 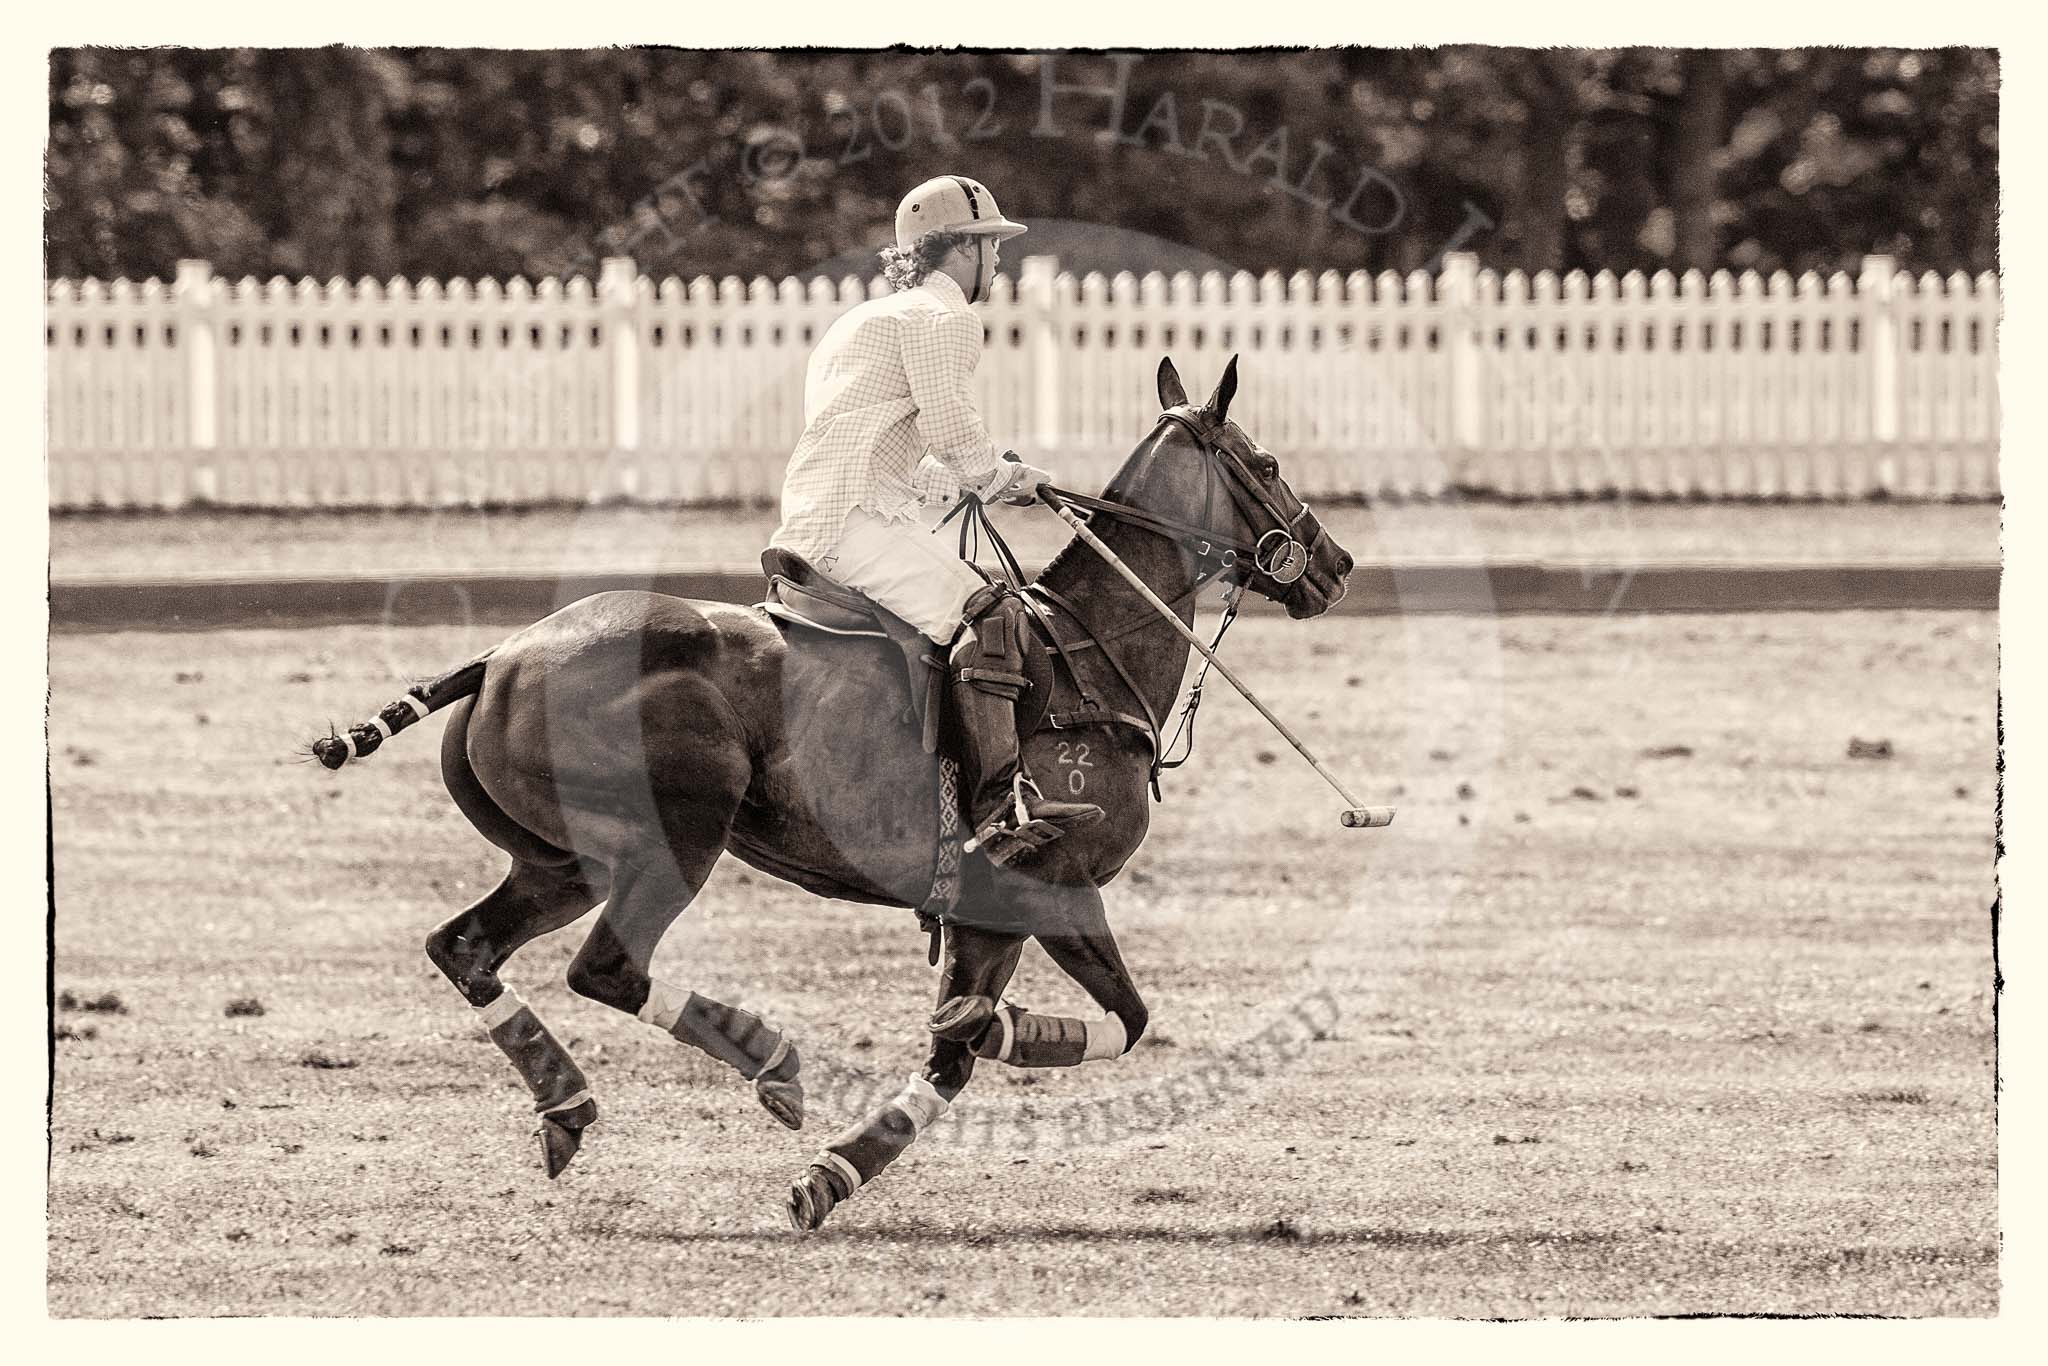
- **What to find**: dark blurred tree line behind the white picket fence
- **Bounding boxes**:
[45,47,1999,279]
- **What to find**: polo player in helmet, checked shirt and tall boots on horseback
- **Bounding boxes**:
[770,176,1102,864]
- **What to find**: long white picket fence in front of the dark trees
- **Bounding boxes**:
[45,254,1999,508]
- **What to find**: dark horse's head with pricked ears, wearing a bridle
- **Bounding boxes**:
[1159,356,1352,618]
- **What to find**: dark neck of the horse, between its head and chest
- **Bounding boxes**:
[1038,483,1194,719]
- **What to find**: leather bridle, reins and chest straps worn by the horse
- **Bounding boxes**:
[948,403,1329,801]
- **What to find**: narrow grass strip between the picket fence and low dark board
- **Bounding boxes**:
[49,500,1999,578]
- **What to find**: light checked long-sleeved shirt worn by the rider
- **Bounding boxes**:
[770,272,1001,561]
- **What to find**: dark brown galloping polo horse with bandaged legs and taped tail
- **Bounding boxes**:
[313,358,1352,1229]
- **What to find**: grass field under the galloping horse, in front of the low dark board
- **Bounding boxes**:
[49,614,1999,1317]
